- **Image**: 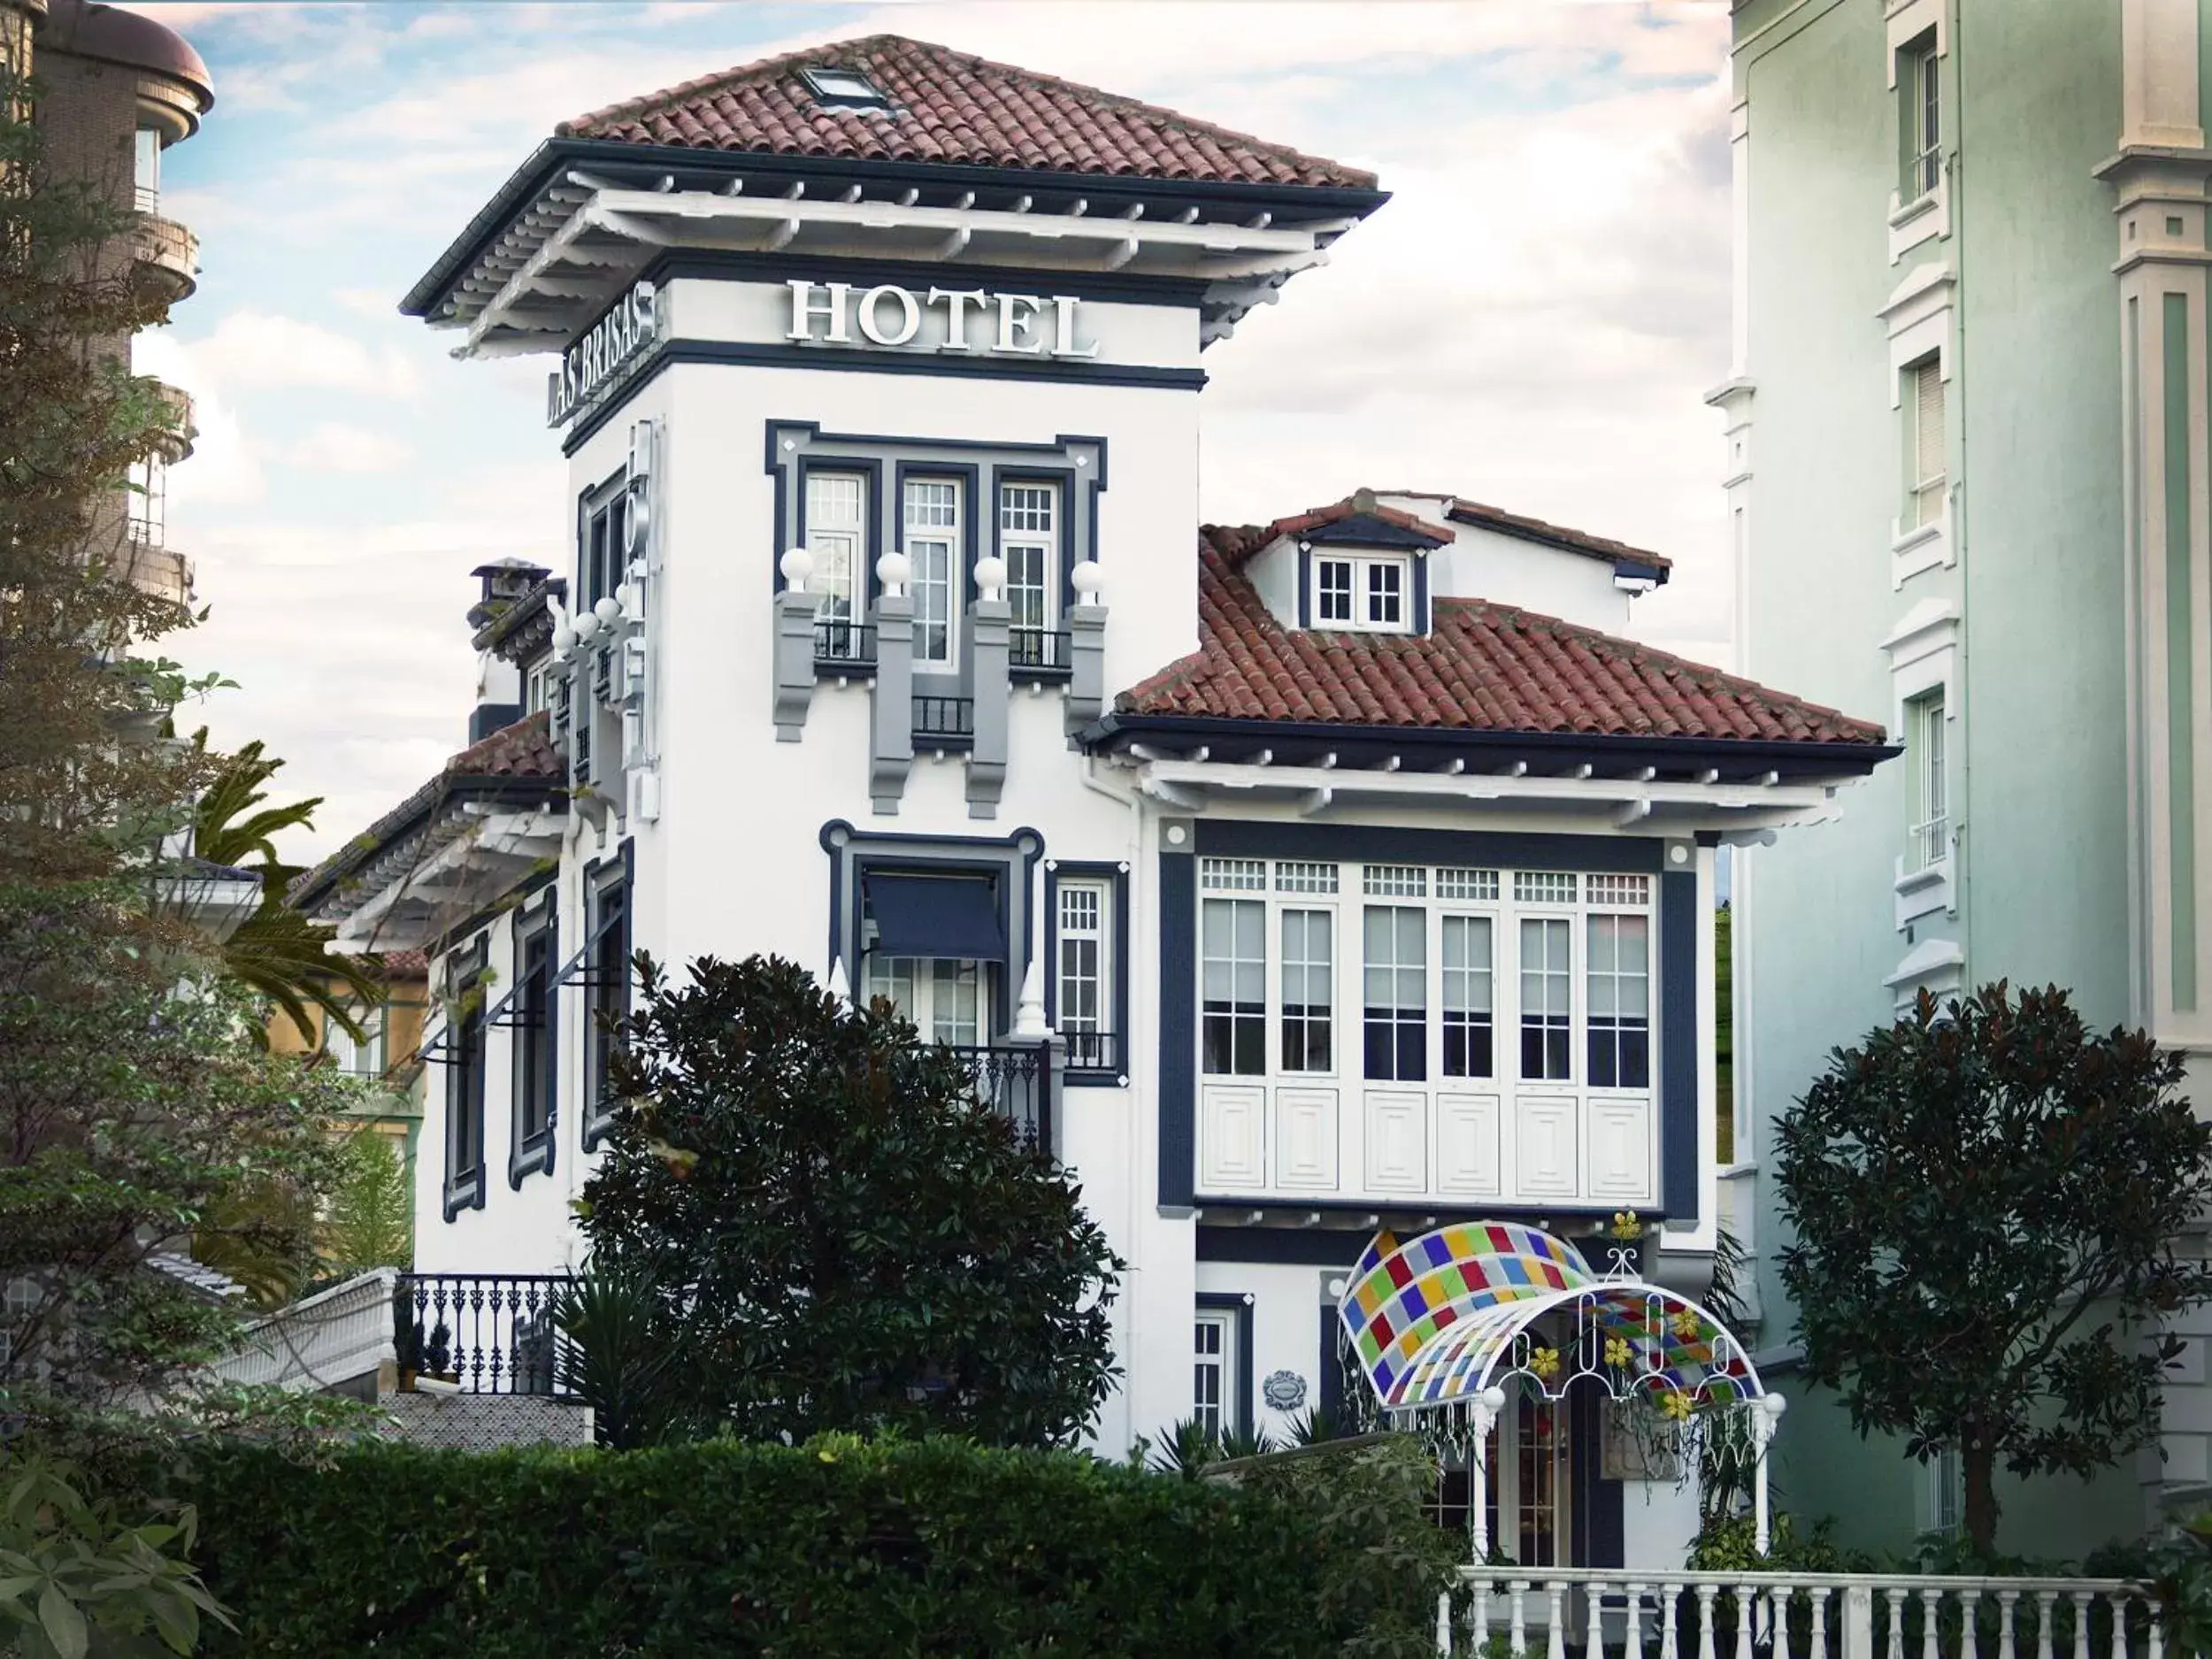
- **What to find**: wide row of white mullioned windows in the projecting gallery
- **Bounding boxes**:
[1199,856,1657,1093]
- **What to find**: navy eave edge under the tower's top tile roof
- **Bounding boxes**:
[401,137,1389,317]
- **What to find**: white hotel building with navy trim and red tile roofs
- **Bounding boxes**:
[285,35,1892,1564]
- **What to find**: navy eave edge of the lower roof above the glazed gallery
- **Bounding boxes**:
[1075,712,1905,783]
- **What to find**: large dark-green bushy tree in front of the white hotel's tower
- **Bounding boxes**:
[580,956,1122,1445]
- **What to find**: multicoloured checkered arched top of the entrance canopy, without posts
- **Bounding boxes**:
[1339,1221,1765,1411]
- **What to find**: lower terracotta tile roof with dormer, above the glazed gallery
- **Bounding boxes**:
[1115,525,1883,743]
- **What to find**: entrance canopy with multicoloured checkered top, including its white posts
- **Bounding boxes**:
[1336,1221,1783,1562]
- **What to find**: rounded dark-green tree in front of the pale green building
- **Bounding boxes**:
[1777,982,2212,1557]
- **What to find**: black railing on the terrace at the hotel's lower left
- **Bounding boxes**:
[392,1274,575,1394]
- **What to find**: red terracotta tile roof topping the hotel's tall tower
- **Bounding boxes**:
[556,35,1376,190]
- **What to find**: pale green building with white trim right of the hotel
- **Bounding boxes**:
[1712,0,2212,1555]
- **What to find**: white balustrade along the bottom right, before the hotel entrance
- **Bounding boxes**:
[1436,1566,2166,1659]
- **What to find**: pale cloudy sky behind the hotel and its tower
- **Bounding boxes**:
[133,0,1730,856]
